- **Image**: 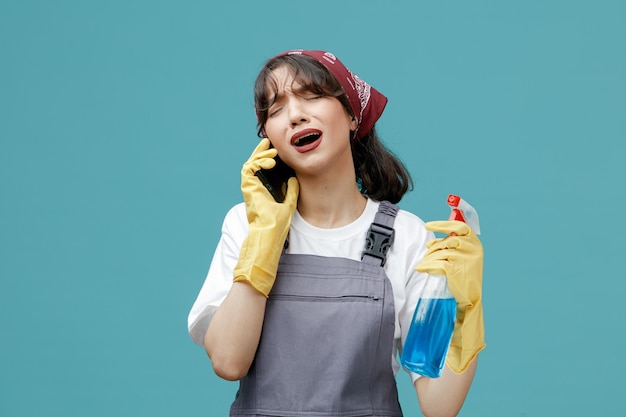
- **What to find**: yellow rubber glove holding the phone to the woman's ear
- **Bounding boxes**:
[233,139,299,297]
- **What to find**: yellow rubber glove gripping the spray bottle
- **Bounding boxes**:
[415,221,486,374]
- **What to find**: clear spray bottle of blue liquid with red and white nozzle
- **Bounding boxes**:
[400,194,480,378]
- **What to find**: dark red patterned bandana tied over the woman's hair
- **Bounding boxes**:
[277,49,387,139]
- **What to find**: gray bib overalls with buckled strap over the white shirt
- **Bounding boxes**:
[230,202,402,417]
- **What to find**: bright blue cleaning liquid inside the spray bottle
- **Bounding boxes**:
[400,298,456,378]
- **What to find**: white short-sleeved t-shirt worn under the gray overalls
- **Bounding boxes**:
[188,199,445,381]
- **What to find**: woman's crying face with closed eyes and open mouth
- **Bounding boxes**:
[265,66,356,174]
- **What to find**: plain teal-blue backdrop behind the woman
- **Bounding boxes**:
[0,0,626,417]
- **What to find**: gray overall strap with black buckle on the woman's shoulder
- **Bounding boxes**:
[361,201,399,266]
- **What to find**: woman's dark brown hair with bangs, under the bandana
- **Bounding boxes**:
[254,55,413,203]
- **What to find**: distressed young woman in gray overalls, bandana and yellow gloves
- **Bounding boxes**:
[189,50,484,417]
